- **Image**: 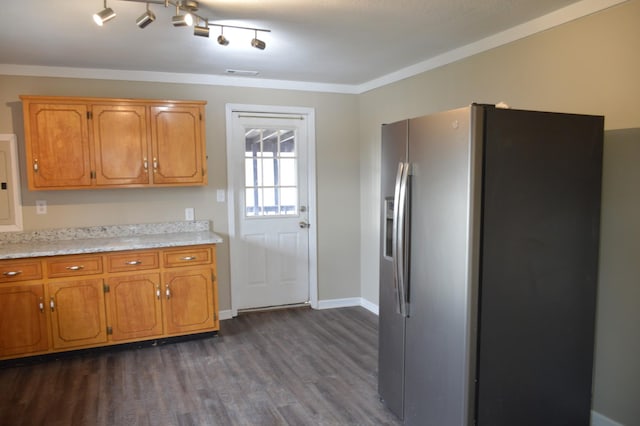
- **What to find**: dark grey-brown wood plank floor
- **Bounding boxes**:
[0,308,400,426]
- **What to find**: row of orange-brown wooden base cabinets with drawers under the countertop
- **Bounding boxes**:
[0,245,220,359]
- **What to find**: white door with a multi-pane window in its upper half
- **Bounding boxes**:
[227,107,315,315]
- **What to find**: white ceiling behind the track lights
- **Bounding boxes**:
[0,0,621,90]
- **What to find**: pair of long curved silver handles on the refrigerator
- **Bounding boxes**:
[392,163,409,317]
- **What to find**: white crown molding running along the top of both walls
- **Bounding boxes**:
[0,0,628,94]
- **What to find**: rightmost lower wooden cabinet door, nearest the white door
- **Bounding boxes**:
[163,268,216,334]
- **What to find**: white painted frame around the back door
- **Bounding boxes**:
[225,104,318,317]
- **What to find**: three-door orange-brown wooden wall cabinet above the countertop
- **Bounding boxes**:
[21,96,207,190]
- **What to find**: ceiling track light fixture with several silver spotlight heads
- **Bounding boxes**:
[93,0,271,50]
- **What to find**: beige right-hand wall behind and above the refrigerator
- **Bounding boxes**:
[359,0,640,426]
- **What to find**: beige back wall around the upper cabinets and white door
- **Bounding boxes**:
[0,76,360,310]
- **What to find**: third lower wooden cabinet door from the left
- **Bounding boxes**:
[107,274,163,341]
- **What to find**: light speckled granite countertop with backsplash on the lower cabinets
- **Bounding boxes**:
[0,221,222,259]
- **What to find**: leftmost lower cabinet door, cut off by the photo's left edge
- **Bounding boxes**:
[0,284,49,357]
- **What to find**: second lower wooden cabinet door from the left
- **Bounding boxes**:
[48,279,107,349]
